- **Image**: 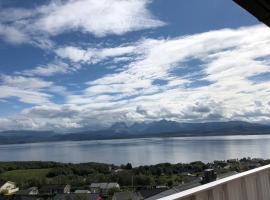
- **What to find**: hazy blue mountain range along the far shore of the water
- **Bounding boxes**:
[0,120,270,144]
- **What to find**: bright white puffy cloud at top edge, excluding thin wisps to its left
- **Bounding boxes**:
[35,0,164,37]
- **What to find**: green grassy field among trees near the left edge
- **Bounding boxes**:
[0,169,51,183]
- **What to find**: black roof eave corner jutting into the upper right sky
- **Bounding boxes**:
[234,0,270,27]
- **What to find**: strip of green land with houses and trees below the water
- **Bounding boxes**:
[0,158,270,200]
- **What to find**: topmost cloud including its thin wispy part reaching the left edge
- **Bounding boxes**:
[0,0,165,48]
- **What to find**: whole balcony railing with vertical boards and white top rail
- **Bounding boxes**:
[159,165,270,200]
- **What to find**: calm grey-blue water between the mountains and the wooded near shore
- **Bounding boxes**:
[0,135,270,166]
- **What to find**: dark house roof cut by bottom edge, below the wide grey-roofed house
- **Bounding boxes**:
[53,193,102,200]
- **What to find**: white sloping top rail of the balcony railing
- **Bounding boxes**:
[158,165,270,200]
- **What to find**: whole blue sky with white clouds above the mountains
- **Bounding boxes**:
[0,0,270,132]
